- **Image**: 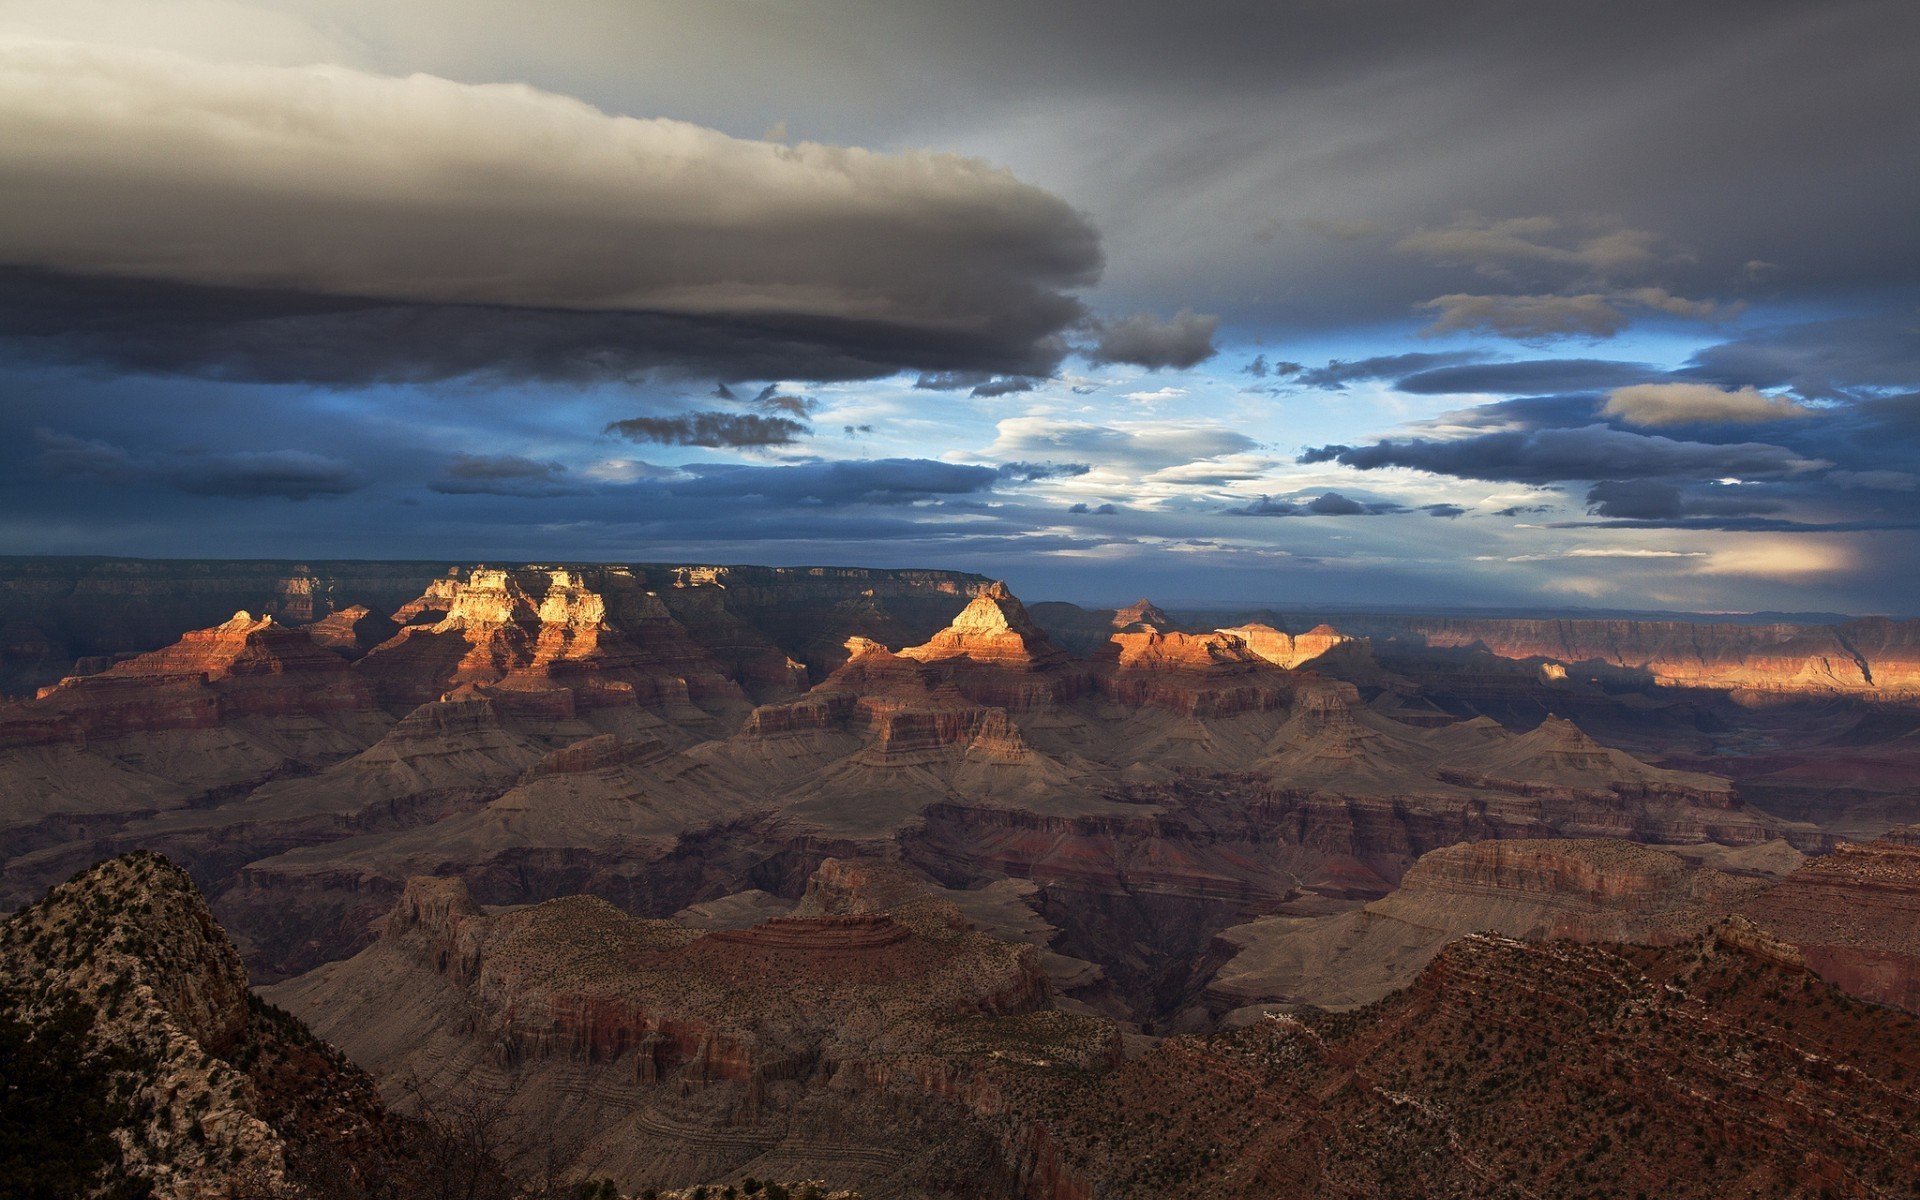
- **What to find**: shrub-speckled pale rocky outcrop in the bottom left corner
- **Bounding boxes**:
[0,854,453,1200]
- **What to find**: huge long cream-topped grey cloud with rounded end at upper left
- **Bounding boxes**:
[0,40,1102,378]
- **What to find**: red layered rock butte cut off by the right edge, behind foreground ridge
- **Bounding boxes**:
[1741,829,1920,1012]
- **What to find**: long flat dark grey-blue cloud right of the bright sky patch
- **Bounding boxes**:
[1300,424,1832,484]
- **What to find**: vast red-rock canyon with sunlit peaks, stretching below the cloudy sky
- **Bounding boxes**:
[0,559,1920,1200]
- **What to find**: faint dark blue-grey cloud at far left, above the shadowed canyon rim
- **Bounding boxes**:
[35,428,363,501]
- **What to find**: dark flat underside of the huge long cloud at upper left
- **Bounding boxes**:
[0,267,1090,386]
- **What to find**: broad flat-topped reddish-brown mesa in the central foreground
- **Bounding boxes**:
[269,864,1117,1196]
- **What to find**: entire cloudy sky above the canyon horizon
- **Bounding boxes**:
[0,0,1920,614]
